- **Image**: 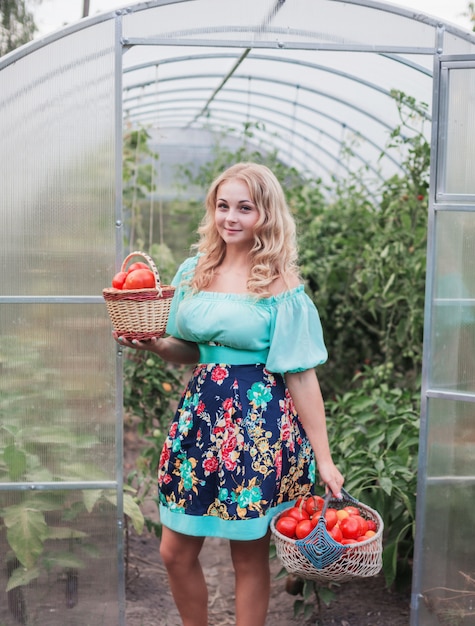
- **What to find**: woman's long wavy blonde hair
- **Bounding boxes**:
[191,163,299,298]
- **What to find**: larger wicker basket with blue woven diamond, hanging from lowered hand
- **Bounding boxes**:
[271,491,384,582]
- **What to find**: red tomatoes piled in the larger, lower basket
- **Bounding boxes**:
[275,496,377,545]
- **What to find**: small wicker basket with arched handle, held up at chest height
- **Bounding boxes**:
[102,251,175,341]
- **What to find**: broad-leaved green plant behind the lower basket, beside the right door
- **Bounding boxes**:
[326,365,420,586]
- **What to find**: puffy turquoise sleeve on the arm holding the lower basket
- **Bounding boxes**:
[266,286,328,374]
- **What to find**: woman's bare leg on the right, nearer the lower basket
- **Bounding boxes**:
[231,533,270,626]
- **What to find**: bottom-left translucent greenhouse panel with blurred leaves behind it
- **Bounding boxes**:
[0,490,120,626]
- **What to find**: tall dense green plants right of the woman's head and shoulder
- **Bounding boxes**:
[296,93,430,395]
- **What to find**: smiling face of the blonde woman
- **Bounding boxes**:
[214,178,259,249]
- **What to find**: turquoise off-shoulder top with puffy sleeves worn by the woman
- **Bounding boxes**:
[167,256,328,374]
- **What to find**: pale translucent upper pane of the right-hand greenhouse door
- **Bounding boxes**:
[444,67,475,194]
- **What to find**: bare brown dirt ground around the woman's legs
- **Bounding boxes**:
[124,422,410,626]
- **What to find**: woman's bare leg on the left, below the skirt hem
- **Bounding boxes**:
[160,526,208,626]
